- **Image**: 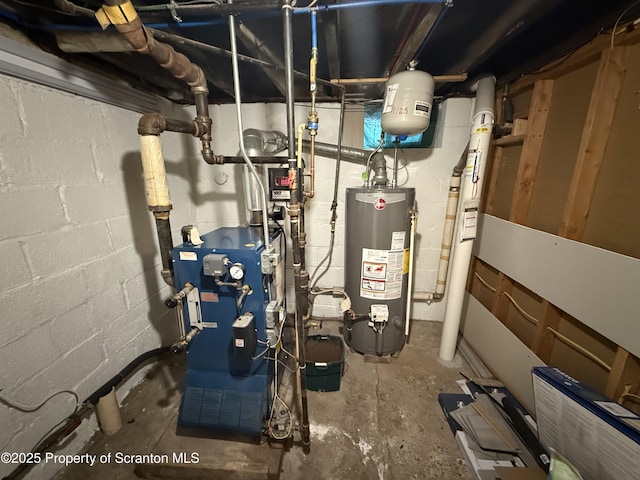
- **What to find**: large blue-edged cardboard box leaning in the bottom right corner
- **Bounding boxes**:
[532,367,640,480]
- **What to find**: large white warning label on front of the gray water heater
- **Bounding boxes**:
[360,248,404,300]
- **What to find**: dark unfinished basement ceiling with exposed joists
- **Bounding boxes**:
[0,0,640,103]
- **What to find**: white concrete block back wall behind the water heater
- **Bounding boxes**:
[202,98,473,321]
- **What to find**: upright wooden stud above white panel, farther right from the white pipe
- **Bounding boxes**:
[559,47,631,240]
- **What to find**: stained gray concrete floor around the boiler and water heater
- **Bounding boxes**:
[58,322,471,480]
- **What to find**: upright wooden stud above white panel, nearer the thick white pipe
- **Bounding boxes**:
[509,80,554,224]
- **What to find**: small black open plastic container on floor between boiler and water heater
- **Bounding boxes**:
[305,335,344,392]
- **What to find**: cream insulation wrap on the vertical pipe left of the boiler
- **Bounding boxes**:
[140,135,171,210]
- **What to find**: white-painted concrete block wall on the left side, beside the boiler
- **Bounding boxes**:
[0,76,199,478]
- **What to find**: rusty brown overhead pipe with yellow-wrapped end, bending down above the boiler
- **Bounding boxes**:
[96,0,216,164]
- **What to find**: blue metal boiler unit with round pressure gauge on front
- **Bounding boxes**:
[172,227,284,436]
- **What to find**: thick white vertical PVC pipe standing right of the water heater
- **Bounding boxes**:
[439,77,496,361]
